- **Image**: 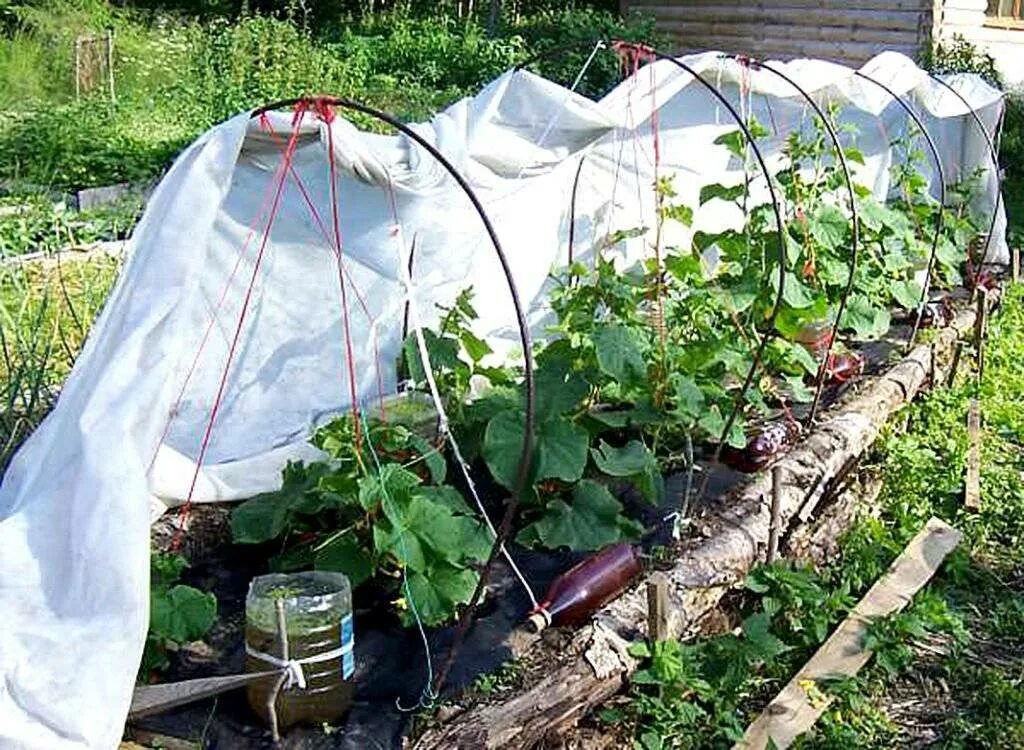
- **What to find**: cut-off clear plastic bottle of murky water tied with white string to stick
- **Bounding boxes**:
[246,571,355,728]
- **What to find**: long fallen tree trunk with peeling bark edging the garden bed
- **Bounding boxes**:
[414,301,976,750]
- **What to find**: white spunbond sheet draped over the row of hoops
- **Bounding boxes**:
[0,53,1006,750]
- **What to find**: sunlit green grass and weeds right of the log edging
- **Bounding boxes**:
[618,286,1024,750]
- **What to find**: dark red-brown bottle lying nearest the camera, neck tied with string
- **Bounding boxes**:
[529,542,641,631]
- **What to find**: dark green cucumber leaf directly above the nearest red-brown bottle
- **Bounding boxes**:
[520,480,642,550]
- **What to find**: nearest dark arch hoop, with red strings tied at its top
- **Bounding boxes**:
[251,96,537,691]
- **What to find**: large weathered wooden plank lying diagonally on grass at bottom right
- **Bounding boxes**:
[734,517,963,750]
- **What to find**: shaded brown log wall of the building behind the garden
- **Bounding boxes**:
[623,0,937,65]
